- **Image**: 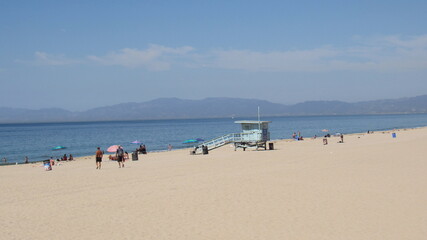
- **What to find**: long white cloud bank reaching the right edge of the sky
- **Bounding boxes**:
[204,35,427,72]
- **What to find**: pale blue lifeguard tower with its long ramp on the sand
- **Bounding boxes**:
[196,121,271,151]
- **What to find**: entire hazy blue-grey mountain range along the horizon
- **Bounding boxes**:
[0,95,427,123]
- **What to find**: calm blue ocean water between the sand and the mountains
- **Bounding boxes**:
[0,114,427,164]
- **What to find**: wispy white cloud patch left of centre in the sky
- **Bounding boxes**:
[87,45,193,71]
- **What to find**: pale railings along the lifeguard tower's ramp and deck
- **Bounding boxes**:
[197,132,265,150]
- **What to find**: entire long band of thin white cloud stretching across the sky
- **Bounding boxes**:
[26,35,427,72]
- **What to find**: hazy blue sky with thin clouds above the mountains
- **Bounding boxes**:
[0,1,427,110]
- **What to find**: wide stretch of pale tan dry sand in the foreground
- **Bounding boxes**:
[0,128,427,240]
